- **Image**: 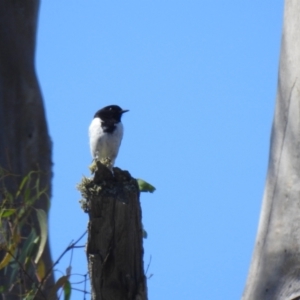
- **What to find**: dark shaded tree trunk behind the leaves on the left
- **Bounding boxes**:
[0,0,53,300]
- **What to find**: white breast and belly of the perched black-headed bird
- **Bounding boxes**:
[89,118,123,164]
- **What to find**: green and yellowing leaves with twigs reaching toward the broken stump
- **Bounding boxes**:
[0,168,86,300]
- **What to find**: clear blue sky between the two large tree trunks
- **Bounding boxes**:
[36,0,283,300]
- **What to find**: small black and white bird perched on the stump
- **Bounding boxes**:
[89,105,128,166]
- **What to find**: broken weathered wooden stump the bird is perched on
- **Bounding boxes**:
[87,164,147,300]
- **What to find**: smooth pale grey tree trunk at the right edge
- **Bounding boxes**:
[242,0,300,300]
